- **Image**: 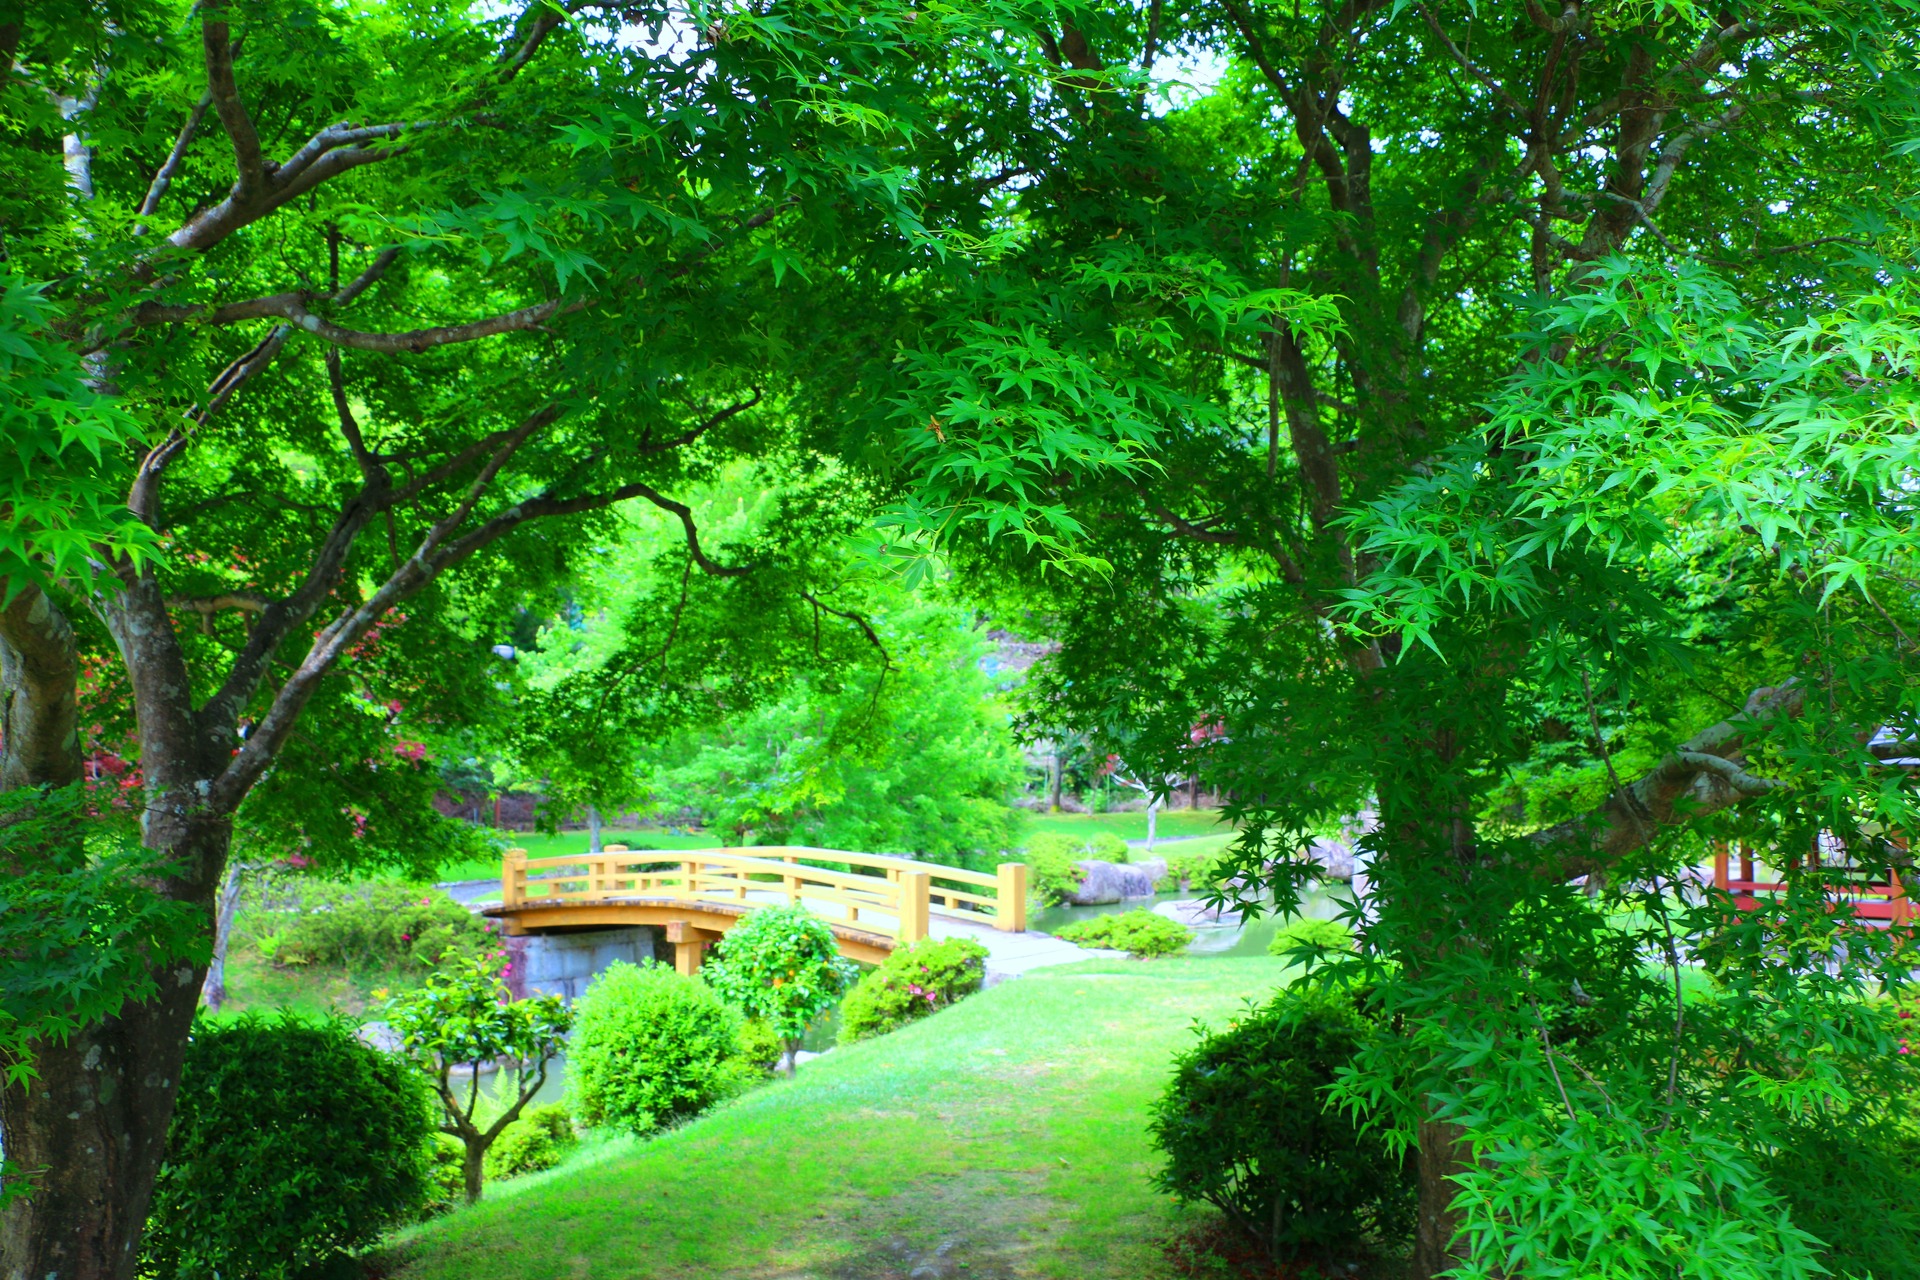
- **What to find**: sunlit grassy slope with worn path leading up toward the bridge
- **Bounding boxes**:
[399,958,1284,1280]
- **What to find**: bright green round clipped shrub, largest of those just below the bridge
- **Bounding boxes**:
[566,961,751,1134]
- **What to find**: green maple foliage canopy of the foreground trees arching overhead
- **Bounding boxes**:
[0,0,1920,1276]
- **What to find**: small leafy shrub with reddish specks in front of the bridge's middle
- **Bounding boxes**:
[705,906,858,1071]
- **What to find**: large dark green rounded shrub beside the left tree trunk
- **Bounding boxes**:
[142,1015,434,1280]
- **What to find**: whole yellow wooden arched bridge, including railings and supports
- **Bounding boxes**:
[484,844,1027,973]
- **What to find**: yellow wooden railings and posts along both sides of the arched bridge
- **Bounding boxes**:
[501,844,1027,942]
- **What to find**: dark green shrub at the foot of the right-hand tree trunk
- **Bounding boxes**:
[1148,990,1417,1261]
